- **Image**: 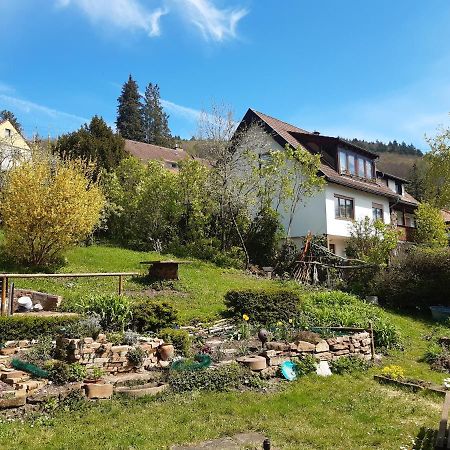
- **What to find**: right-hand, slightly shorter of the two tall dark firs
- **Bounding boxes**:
[142,83,174,147]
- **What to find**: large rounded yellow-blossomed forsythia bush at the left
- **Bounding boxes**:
[0,157,104,266]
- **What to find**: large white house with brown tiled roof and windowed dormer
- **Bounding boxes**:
[237,109,418,256]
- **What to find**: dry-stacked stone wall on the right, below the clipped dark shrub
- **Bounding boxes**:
[261,332,372,366]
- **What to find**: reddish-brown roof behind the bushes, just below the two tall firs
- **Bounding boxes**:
[125,139,192,172]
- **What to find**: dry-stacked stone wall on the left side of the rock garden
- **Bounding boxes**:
[56,334,169,373]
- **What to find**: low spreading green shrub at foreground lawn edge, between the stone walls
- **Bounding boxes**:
[169,363,260,392]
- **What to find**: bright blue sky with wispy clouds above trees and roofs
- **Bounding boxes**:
[0,0,450,149]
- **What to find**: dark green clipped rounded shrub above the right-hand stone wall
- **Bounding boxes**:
[225,289,299,324]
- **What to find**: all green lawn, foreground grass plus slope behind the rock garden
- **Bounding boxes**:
[0,246,445,450]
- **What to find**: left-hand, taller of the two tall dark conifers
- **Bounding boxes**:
[116,75,144,141]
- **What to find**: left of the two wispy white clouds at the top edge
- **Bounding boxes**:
[56,0,168,36]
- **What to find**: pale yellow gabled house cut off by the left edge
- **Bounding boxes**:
[0,120,31,171]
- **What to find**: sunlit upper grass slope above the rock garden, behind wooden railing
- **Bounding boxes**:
[0,245,269,322]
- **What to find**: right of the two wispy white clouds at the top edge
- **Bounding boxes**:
[176,0,248,41]
